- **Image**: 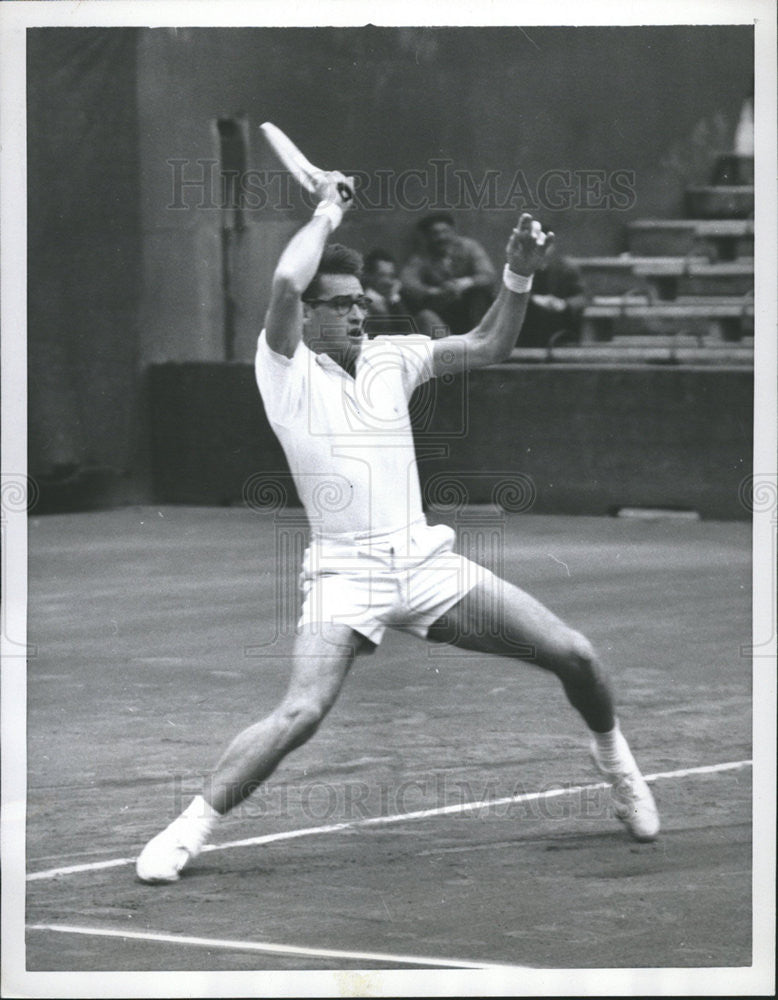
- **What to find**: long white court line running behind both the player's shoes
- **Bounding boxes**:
[27,760,753,882]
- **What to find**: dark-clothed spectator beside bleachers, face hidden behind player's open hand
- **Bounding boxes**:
[518,241,586,347]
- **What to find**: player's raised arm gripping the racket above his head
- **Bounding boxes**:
[265,171,354,358]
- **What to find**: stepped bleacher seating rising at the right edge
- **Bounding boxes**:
[513,153,754,364]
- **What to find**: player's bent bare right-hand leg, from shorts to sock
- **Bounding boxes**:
[429,576,615,733]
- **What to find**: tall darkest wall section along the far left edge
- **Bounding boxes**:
[27,28,142,496]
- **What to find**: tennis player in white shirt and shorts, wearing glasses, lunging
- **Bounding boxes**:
[136,172,659,883]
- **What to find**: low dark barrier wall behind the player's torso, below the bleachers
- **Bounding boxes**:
[150,362,753,519]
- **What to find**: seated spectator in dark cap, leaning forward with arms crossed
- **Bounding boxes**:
[402,212,495,337]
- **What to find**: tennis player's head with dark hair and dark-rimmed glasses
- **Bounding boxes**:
[303,274,366,360]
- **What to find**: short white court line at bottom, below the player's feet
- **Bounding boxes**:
[27,924,530,970]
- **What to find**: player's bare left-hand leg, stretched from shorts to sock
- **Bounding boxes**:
[203,625,372,814]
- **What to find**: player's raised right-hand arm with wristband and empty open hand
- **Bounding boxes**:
[432,212,554,376]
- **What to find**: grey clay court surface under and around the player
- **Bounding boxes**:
[27,507,752,971]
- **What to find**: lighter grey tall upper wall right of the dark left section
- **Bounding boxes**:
[139,26,753,360]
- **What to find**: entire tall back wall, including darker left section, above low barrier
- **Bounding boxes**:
[28,26,753,512]
